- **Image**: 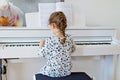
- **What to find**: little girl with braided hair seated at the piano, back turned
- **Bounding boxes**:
[39,11,75,77]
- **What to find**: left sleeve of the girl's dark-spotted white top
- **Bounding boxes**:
[38,39,49,57]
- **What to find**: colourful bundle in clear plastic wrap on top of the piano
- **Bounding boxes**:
[0,0,24,26]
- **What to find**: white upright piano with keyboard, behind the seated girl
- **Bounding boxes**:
[0,27,120,80]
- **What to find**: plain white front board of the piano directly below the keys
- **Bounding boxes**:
[0,44,120,58]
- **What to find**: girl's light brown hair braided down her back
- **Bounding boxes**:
[49,11,67,44]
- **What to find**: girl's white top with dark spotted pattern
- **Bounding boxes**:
[38,34,75,77]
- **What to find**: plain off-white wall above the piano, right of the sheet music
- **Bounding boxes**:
[65,0,120,27]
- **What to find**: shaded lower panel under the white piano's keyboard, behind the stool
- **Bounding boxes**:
[2,55,120,80]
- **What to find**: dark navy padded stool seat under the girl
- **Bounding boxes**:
[35,72,93,80]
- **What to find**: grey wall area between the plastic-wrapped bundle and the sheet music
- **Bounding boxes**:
[10,0,59,13]
